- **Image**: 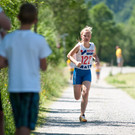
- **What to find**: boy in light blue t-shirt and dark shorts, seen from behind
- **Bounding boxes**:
[0,3,51,135]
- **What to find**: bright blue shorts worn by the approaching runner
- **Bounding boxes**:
[73,68,91,85]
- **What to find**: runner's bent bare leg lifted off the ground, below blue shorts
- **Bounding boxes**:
[74,84,82,100]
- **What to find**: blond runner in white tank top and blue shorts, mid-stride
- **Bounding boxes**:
[67,26,99,122]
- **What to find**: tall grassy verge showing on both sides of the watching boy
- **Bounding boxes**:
[0,63,68,135]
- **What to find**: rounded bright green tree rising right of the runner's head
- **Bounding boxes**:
[89,3,119,62]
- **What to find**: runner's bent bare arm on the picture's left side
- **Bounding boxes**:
[67,45,81,67]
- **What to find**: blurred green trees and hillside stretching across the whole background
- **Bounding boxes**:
[0,0,135,66]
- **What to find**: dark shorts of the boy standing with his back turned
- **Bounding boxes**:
[10,92,39,130]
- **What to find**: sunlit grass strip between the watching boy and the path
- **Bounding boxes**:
[37,66,68,128]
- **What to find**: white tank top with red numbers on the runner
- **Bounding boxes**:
[76,42,95,70]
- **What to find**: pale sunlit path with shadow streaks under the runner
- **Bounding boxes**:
[35,67,135,135]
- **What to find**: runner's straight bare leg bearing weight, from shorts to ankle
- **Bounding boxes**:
[81,81,91,115]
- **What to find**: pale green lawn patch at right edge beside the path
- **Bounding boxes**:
[105,73,135,99]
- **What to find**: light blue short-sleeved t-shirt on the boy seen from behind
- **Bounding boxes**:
[0,30,52,92]
